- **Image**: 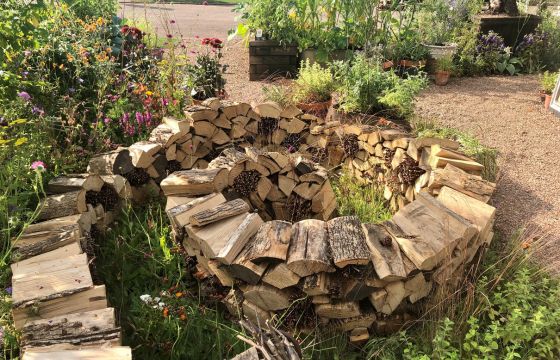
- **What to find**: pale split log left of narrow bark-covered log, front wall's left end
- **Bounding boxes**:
[166,193,226,233]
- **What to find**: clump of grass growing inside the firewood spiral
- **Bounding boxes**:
[333,174,392,223]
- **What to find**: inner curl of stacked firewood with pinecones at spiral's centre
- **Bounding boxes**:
[161,147,336,222]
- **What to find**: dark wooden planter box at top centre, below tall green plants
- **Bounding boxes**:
[249,40,299,81]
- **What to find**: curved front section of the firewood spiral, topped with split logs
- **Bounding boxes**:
[162,160,495,343]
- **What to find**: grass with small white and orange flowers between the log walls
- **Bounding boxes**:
[96,204,246,359]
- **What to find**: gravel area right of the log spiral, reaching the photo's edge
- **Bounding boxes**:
[417,76,560,267]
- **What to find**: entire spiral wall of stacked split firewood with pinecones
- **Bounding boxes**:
[8,99,495,358]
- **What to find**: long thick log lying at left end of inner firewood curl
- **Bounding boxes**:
[161,169,228,196]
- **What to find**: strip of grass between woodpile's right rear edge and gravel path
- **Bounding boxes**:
[411,119,498,182]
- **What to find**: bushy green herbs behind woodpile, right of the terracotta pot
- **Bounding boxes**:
[335,55,427,118]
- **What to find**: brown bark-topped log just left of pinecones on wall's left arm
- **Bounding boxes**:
[37,190,87,220]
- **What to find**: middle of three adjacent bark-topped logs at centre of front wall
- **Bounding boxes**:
[286,219,334,277]
